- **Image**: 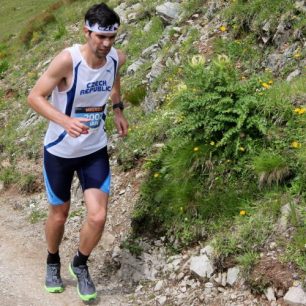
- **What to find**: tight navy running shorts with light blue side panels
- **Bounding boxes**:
[43,147,110,205]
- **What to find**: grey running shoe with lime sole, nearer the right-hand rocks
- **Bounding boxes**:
[69,263,97,301]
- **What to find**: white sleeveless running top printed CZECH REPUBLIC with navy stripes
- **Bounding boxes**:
[44,44,119,158]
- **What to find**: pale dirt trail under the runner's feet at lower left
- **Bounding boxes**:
[0,195,127,306]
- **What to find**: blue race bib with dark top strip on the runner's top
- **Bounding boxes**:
[75,105,105,131]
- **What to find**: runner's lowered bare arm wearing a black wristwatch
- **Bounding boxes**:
[110,50,129,136]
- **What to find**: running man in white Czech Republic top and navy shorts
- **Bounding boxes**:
[28,3,128,301]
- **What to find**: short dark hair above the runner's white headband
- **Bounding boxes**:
[85,3,120,27]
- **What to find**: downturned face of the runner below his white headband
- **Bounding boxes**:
[85,29,116,59]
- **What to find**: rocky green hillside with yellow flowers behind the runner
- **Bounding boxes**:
[0,0,306,305]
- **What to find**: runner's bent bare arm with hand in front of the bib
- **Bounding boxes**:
[28,51,88,137]
